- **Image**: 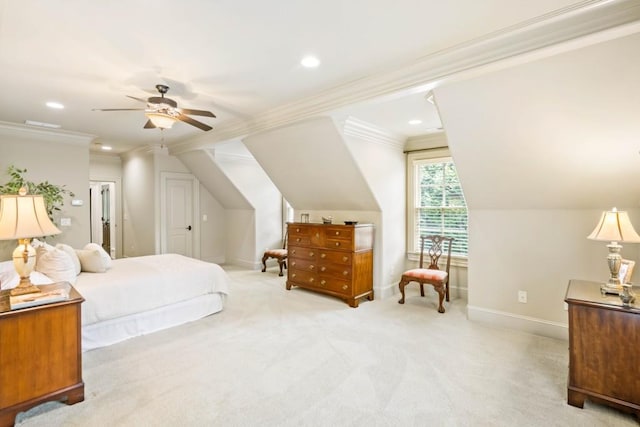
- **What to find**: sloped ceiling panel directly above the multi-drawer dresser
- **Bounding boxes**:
[243,117,379,211]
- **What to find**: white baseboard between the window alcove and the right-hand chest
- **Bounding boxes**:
[467,305,569,341]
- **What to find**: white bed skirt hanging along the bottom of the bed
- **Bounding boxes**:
[82,293,225,351]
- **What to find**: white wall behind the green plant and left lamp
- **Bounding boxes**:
[0,122,93,259]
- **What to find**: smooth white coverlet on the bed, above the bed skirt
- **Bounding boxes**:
[74,254,229,327]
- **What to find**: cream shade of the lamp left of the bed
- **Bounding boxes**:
[0,194,61,240]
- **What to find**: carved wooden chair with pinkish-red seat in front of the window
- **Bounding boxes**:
[398,235,453,313]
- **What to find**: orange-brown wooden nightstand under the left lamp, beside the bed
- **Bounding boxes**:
[0,285,84,427]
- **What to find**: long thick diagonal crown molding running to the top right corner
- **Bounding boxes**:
[169,0,640,153]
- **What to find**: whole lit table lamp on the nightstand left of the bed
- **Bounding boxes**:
[0,188,61,295]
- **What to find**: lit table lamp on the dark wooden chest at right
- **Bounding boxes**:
[587,208,640,295]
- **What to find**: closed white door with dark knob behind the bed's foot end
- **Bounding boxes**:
[164,178,194,257]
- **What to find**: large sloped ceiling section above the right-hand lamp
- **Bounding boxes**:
[434,30,640,209]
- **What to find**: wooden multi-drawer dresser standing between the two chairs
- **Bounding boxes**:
[287,222,374,307]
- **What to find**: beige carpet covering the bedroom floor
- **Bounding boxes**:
[17,268,637,427]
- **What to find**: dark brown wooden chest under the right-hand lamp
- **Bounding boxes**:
[565,280,640,416]
